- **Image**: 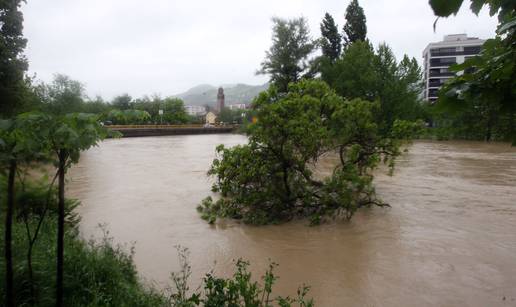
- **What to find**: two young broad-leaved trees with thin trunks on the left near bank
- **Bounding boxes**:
[0,113,111,306]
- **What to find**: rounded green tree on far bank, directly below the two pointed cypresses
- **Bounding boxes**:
[321,41,422,133]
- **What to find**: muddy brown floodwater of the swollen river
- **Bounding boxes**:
[67,134,516,306]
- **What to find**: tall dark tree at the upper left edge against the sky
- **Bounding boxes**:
[0,0,28,117]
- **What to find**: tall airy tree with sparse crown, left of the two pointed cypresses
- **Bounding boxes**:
[257,18,316,92]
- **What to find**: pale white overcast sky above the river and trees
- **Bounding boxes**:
[23,0,496,99]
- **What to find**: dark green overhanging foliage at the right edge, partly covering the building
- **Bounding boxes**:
[430,0,516,145]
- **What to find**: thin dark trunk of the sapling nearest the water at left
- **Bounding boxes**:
[56,149,66,307]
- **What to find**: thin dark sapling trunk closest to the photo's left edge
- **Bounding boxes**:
[5,160,16,307]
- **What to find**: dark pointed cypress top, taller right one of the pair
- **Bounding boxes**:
[344,0,367,45]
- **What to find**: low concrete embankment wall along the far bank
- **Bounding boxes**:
[109,127,236,137]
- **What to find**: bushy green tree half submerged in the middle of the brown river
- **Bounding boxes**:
[197,81,417,224]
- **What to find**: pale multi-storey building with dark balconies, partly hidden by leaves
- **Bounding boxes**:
[423,34,485,103]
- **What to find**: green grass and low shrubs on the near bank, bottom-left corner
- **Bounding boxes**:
[0,209,165,307]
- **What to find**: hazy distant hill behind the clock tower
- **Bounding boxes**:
[175,83,269,106]
